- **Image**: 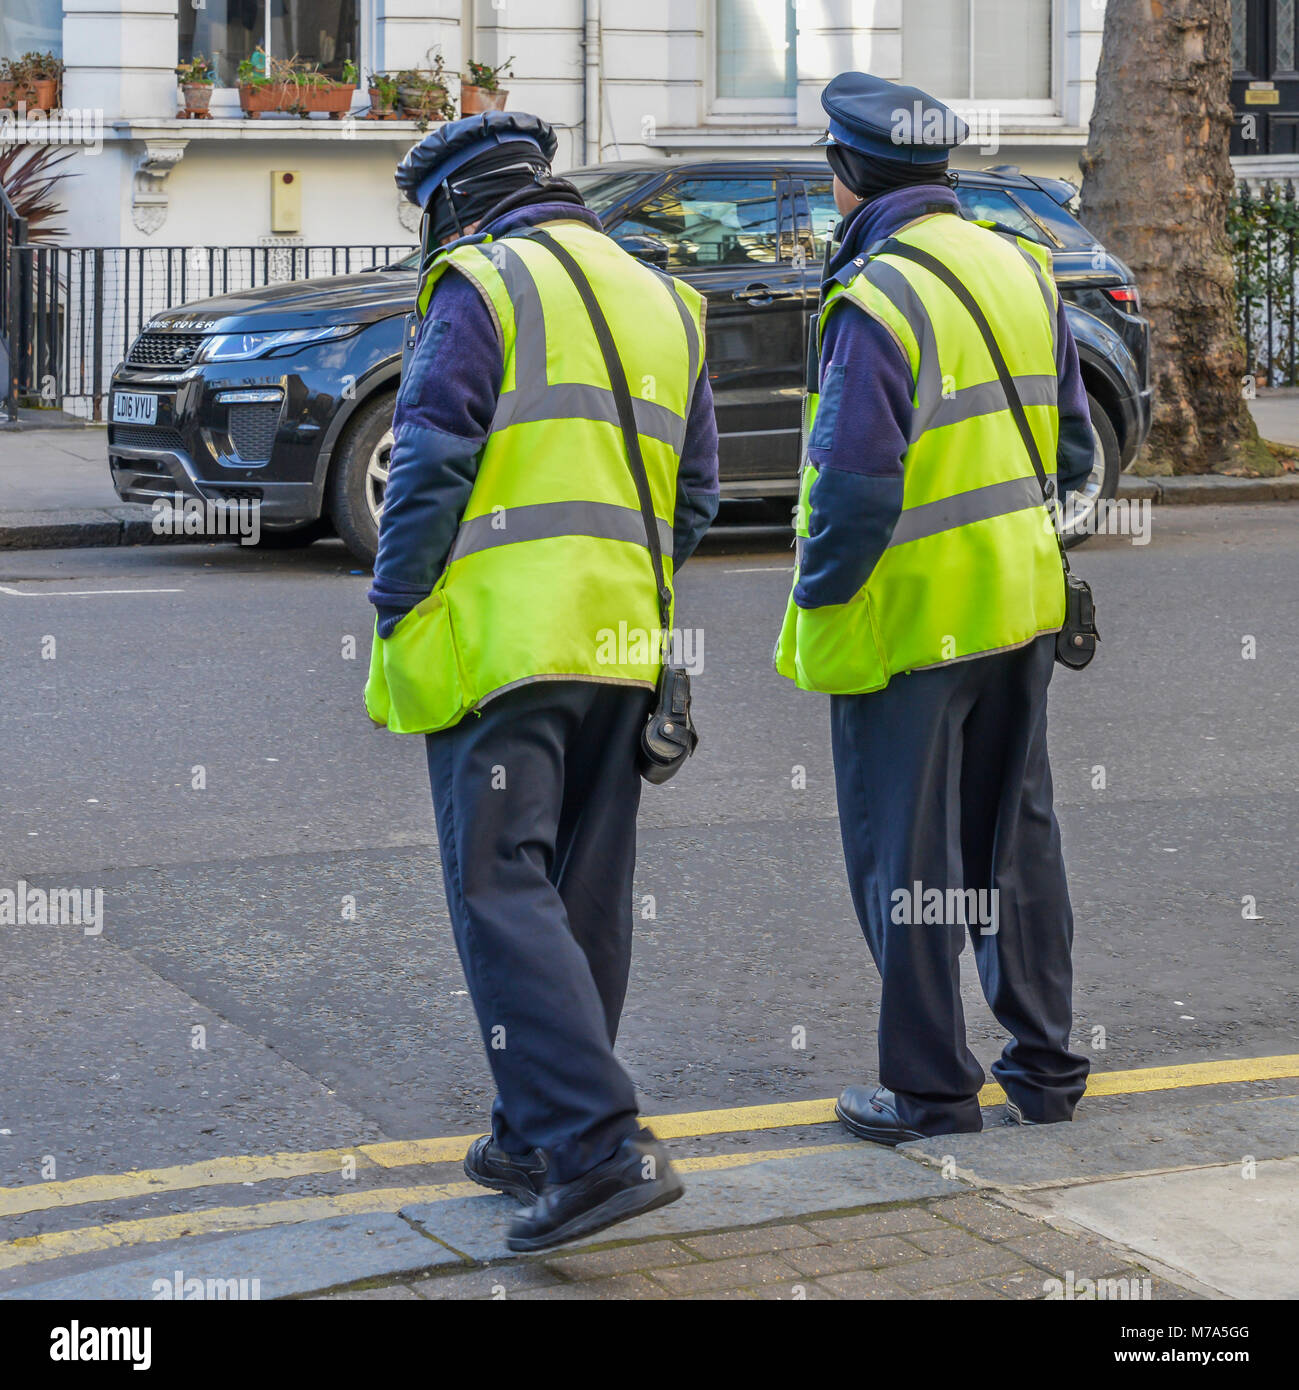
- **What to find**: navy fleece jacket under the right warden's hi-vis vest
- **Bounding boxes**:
[793,186,1092,609]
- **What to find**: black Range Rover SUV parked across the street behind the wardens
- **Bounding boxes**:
[108,160,1150,563]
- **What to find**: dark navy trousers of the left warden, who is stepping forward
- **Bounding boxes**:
[425,681,653,1182]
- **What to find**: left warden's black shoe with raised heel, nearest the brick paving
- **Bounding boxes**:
[506,1130,685,1251]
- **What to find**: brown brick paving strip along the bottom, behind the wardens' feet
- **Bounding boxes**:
[322,1195,1203,1300]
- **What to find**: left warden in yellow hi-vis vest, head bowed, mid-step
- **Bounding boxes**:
[365,111,718,1250]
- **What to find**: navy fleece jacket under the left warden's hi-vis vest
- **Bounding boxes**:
[370,203,718,637]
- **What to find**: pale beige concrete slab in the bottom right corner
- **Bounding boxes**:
[1032,1158,1299,1298]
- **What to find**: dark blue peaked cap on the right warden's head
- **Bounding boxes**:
[818,72,970,165]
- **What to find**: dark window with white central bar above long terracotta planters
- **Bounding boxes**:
[181,0,360,86]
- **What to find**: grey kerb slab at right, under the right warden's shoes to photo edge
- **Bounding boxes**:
[903,1095,1299,1187]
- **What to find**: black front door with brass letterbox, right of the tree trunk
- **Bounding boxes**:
[1231,0,1299,154]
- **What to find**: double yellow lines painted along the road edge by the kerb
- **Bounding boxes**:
[0,1054,1299,1269]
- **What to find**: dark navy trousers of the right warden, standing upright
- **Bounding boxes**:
[831,637,1088,1134]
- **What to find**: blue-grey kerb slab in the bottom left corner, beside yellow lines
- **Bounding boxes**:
[4,1212,461,1300]
